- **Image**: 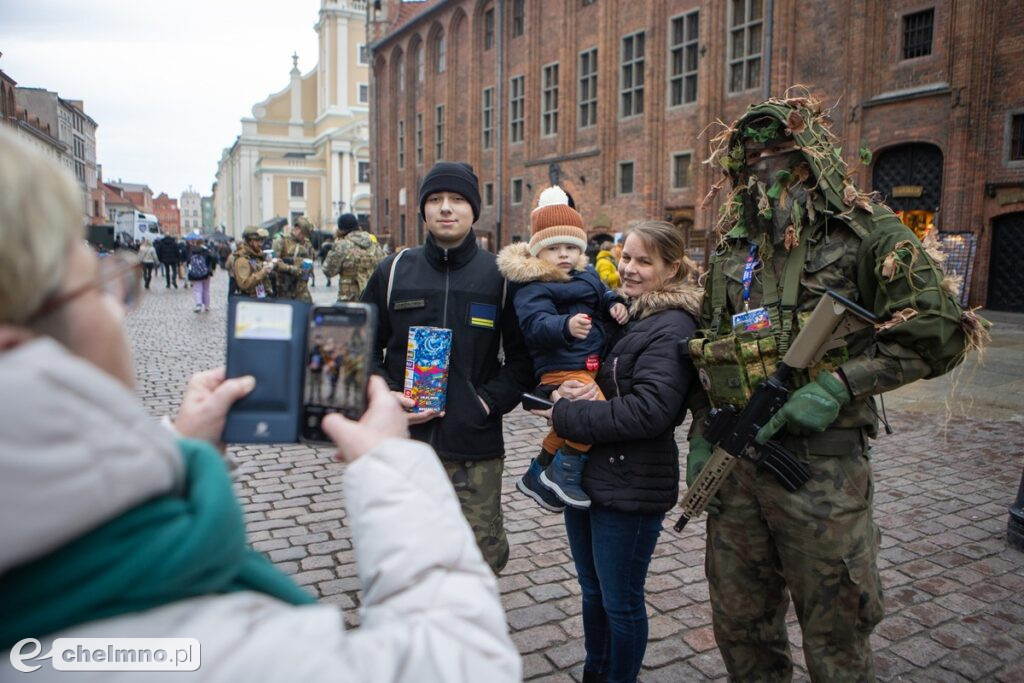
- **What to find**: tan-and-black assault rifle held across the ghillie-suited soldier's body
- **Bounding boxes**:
[675,290,878,531]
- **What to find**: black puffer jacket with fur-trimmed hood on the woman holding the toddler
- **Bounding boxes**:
[552,284,700,513]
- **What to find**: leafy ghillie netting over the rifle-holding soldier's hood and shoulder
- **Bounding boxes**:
[701,86,990,358]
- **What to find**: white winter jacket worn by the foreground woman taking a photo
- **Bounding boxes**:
[0,340,521,683]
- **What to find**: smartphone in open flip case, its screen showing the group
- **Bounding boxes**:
[300,302,377,443]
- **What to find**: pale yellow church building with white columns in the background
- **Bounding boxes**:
[214,0,371,238]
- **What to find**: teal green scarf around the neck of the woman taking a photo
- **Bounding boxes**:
[0,439,315,650]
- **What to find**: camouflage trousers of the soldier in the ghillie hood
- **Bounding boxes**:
[706,430,884,681]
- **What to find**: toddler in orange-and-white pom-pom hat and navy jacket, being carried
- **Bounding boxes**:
[498,185,629,512]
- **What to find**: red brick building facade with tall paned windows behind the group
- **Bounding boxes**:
[368,0,1024,310]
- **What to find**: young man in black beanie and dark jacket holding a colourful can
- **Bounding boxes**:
[361,162,534,573]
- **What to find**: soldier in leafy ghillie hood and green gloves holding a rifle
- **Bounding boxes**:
[686,92,987,681]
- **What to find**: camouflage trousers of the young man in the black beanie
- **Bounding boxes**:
[441,458,509,574]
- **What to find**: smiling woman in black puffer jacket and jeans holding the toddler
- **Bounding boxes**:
[539,221,701,683]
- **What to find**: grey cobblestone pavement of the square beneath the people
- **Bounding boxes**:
[128,271,1024,683]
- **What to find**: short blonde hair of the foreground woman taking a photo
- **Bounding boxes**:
[0,127,84,325]
